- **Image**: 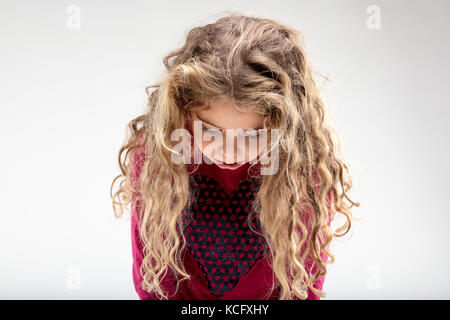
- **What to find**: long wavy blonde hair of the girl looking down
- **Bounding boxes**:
[110,12,359,300]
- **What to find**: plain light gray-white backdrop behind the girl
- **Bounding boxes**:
[0,0,450,299]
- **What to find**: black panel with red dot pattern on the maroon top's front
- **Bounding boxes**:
[184,174,267,297]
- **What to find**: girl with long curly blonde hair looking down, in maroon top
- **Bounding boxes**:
[111,14,359,300]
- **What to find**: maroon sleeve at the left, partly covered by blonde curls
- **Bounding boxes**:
[131,148,182,300]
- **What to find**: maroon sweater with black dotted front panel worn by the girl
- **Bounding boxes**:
[131,149,332,300]
